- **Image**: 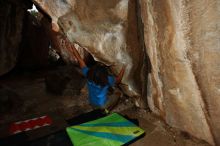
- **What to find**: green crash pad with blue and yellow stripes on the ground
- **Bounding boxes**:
[66,113,144,146]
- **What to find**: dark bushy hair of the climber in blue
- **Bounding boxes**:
[87,64,108,87]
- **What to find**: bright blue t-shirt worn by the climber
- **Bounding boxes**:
[82,67,115,107]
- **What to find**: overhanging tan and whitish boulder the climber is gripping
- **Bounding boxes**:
[34,0,147,102]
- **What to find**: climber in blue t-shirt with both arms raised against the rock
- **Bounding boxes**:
[62,40,126,110]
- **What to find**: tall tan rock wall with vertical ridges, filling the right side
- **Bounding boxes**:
[139,0,220,145]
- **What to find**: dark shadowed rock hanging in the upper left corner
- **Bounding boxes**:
[0,0,29,75]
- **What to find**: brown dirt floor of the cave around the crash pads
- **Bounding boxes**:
[0,66,209,146]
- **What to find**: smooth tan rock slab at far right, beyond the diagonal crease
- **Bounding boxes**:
[189,0,220,145]
